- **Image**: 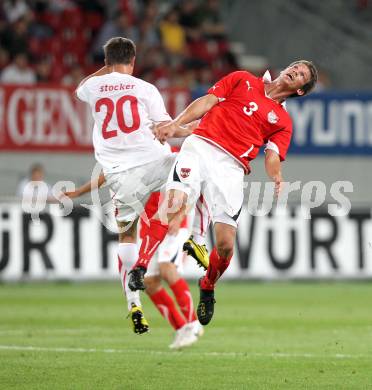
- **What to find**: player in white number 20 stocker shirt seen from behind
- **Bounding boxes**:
[76,37,190,333]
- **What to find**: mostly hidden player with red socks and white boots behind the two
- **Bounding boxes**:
[64,173,208,349]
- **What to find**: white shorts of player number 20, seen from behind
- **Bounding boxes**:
[104,153,176,222]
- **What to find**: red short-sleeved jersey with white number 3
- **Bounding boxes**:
[193,71,292,172]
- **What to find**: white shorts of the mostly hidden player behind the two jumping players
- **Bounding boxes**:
[146,228,189,276]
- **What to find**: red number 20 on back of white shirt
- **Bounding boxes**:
[95,95,141,139]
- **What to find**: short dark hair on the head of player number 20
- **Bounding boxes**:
[103,37,136,65]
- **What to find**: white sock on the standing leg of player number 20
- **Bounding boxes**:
[118,243,141,310]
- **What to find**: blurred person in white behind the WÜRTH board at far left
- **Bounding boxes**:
[16,164,51,200]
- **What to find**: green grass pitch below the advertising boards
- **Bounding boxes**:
[0,282,372,390]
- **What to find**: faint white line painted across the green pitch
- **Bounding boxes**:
[0,345,372,359]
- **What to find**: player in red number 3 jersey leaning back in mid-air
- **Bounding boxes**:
[129,60,317,325]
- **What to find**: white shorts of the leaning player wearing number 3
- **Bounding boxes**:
[167,135,244,227]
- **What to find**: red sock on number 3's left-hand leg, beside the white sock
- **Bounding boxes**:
[133,219,168,269]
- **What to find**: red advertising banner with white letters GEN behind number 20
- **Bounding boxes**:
[0,85,190,152]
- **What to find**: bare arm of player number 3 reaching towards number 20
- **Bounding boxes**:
[157,94,219,142]
